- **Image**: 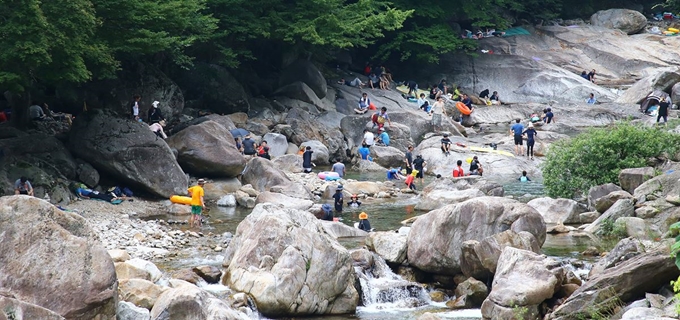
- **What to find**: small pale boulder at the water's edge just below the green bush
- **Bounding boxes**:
[527,197,586,224]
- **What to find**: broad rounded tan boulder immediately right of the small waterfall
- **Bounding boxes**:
[408,197,546,275]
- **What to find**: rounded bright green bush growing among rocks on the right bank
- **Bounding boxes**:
[542,123,680,198]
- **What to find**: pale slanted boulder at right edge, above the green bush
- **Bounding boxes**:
[616,67,680,103]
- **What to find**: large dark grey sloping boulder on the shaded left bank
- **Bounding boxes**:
[68,111,188,197]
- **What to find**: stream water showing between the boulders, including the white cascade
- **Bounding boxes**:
[147,168,603,320]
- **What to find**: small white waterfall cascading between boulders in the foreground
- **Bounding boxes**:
[355,253,431,310]
